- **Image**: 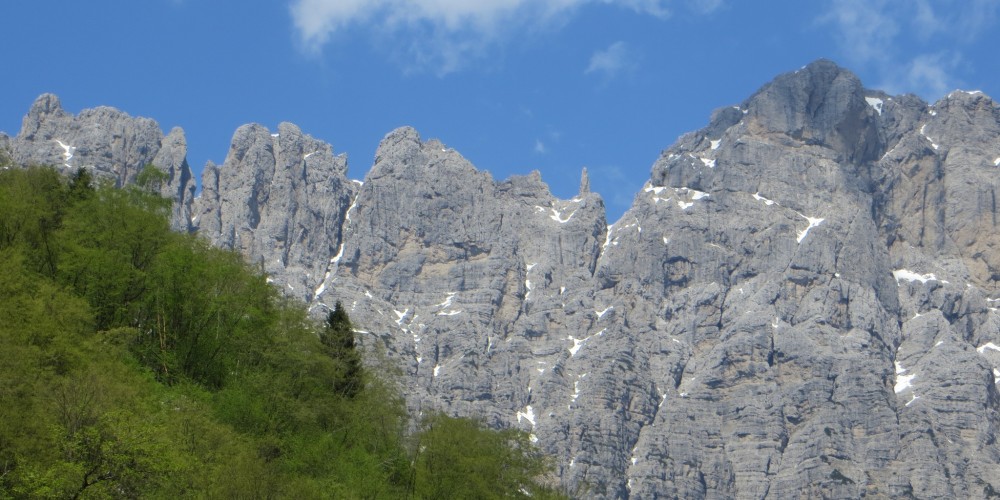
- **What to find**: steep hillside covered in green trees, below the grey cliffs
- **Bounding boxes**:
[0,165,559,498]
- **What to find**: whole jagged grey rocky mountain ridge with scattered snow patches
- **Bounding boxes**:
[0,61,1000,498]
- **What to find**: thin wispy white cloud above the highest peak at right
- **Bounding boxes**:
[819,0,1000,100]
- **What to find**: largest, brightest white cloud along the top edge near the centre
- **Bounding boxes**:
[290,0,676,74]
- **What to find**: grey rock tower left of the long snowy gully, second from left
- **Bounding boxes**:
[194,123,357,302]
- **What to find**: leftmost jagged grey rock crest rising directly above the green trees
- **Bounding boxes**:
[10,94,195,231]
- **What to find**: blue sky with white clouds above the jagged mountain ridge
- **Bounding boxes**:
[0,0,1000,221]
